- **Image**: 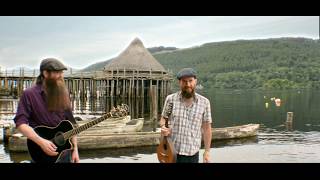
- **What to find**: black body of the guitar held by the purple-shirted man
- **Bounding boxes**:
[27,120,73,163]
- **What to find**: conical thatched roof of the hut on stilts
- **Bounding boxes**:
[104,38,165,72]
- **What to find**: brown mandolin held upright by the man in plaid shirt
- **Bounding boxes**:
[157,103,177,163]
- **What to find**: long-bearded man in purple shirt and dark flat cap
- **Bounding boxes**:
[14,58,79,162]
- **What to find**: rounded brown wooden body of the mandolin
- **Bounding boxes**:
[157,136,177,163]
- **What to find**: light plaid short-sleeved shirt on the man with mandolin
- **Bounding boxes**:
[162,91,212,156]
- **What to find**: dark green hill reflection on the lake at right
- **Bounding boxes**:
[202,90,320,131]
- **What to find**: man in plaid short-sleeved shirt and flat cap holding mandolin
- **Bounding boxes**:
[160,68,212,163]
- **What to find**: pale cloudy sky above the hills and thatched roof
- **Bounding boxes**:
[0,16,319,70]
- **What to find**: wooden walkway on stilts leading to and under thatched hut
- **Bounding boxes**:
[0,69,173,121]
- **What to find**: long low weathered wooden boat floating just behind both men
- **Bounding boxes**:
[8,124,260,152]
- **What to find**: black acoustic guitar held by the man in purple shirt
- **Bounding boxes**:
[27,104,129,163]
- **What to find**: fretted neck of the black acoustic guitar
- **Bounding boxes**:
[63,113,111,140]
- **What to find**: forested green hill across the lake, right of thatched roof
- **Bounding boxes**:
[154,38,320,89]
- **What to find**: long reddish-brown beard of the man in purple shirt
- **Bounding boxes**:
[44,79,71,111]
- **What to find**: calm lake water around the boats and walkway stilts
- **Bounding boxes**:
[0,90,320,163]
